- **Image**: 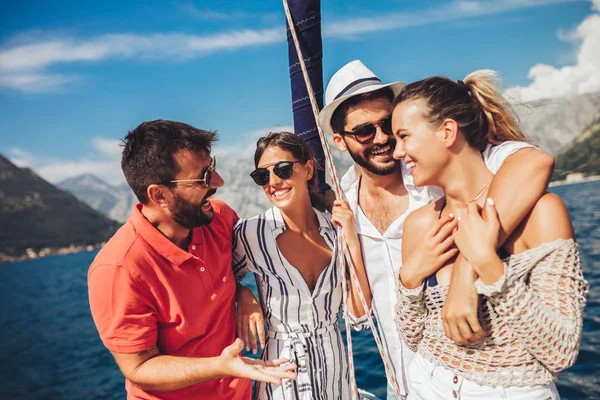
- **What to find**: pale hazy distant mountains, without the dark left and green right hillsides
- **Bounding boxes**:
[58,92,600,222]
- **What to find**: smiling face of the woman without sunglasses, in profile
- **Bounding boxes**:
[392,99,449,186]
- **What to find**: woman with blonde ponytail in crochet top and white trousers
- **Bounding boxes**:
[392,71,588,400]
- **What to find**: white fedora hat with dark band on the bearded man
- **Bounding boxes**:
[319,60,405,134]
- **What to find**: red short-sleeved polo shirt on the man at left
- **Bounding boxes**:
[88,201,252,400]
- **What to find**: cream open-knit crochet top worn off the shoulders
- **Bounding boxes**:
[396,239,589,387]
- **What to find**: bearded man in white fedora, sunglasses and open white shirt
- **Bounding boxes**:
[319,60,554,399]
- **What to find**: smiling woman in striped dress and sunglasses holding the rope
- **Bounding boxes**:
[233,132,371,400]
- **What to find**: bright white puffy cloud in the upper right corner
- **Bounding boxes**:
[506,4,600,102]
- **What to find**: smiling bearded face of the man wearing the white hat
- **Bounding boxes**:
[334,98,399,175]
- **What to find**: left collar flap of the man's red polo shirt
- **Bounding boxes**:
[129,203,192,267]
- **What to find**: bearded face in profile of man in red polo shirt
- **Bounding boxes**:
[169,150,224,229]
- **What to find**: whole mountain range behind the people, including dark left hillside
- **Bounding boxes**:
[0,92,600,261]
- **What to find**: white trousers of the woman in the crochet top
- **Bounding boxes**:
[407,354,560,400]
